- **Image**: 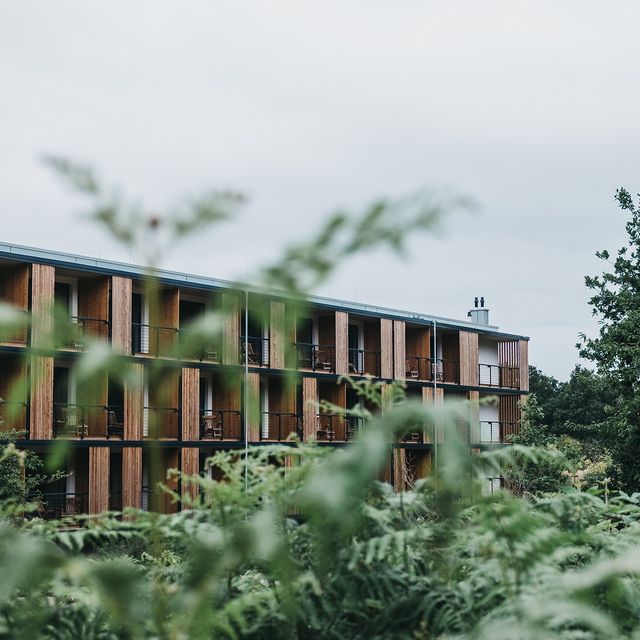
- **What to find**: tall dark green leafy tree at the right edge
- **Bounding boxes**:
[577,189,640,489]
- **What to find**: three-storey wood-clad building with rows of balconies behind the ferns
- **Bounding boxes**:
[0,244,528,515]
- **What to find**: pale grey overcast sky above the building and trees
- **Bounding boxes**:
[0,0,640,378]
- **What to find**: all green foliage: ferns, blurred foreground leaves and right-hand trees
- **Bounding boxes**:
[0,168,640,640]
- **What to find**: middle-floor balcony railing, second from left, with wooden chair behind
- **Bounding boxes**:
[53,402,124,438]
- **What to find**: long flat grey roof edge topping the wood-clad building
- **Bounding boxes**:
[0,242,529,340]
